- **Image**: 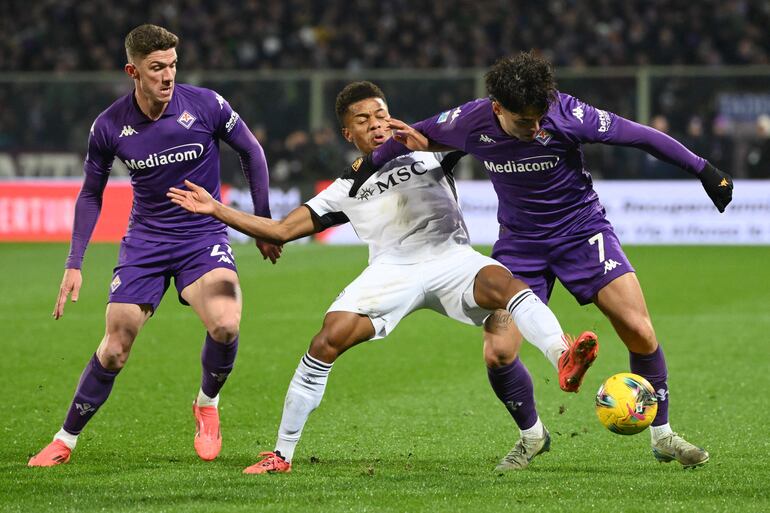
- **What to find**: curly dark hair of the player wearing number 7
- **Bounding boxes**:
[484,51,556,114]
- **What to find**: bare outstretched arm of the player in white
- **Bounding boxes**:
[166,180,320,244]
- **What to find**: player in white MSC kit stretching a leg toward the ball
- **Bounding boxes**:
[168,82,598,474]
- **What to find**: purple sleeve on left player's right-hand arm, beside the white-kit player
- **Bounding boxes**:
[214,93,272,218]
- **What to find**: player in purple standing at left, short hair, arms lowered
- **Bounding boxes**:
[29,25,280,467]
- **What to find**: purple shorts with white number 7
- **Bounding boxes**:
[492,221,634,305]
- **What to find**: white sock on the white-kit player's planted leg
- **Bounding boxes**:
[275,353,332,461]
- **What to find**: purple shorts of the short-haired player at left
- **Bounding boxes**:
[108,237,237,311]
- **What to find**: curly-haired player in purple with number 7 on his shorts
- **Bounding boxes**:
[359,52,733,467]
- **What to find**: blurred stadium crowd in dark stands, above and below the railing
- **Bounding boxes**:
[0,0,770,184]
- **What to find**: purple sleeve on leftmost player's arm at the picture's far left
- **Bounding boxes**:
[64,119,115,269]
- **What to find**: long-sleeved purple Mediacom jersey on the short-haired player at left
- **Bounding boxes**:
[66,84,270,268]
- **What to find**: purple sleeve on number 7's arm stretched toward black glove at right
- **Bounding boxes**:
[553,93,706,176]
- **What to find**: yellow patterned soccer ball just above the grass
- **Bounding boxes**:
[596,372,658,435]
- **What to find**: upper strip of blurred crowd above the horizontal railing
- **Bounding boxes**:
[0,0,770,71]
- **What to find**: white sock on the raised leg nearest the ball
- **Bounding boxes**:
[507,289,567,368]
